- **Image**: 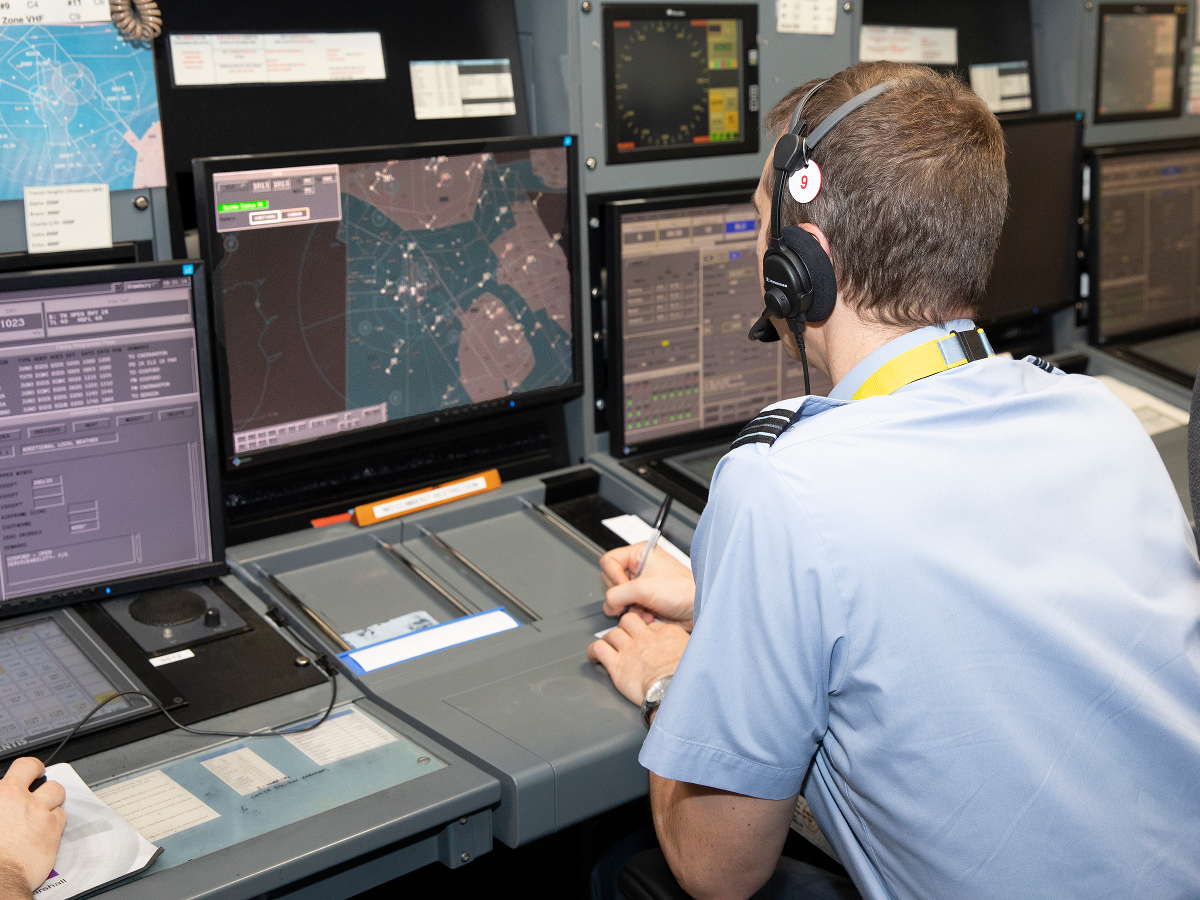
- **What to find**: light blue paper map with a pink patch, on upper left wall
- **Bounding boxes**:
[0,25,167,200]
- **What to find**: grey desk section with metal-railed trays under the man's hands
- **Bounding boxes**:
[227,474,692,846]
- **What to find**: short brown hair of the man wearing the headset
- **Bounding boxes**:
[764,62,1008,328]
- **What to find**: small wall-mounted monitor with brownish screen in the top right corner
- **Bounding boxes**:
[1096,4,1188,122]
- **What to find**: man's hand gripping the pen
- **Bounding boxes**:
[600,541,696,628]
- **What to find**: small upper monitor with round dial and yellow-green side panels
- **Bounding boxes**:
[602,4,758,166]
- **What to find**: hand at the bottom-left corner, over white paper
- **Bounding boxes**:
[0,756,67,900]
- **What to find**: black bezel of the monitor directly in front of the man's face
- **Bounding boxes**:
[601,181,772,457]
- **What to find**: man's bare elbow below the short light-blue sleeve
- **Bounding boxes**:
[650,772,796,900]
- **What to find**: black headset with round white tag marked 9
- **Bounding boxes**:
[748,79,895,394]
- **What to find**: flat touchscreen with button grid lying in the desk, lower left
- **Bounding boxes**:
[0,618,149,755]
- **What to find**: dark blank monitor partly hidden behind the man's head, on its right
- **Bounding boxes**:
[976,113,1084,325]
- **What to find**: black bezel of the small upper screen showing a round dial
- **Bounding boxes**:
[601,2,760,166]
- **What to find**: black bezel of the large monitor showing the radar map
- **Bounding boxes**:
[192,134,583,473]
